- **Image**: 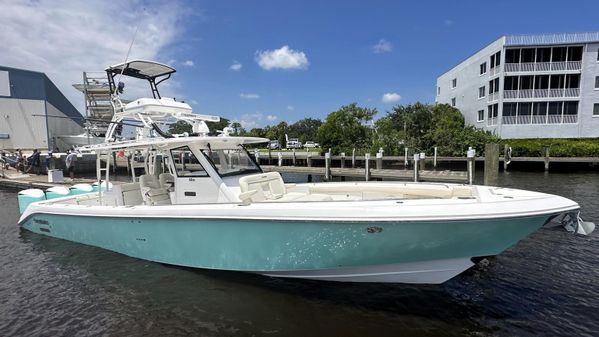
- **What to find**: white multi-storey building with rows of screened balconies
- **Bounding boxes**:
[436,32,599,139]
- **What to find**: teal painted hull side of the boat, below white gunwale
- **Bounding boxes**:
[21,213,549,283]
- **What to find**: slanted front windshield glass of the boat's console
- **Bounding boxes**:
[202,147,262,177]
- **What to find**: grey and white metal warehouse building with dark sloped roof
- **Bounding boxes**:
[0,66,84,151]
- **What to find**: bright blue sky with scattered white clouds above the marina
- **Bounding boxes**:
[0,0,599,129]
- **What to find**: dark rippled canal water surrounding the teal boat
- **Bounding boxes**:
[0,172,599,336]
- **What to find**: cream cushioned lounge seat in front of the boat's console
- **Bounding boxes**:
[239,172,333,202]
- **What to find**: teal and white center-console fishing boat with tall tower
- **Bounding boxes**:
[19,61,594,284]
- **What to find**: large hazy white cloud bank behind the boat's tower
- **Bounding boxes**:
[0,0,187,112]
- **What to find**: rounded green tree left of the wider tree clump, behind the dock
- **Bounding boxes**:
[316,103,377,153]
